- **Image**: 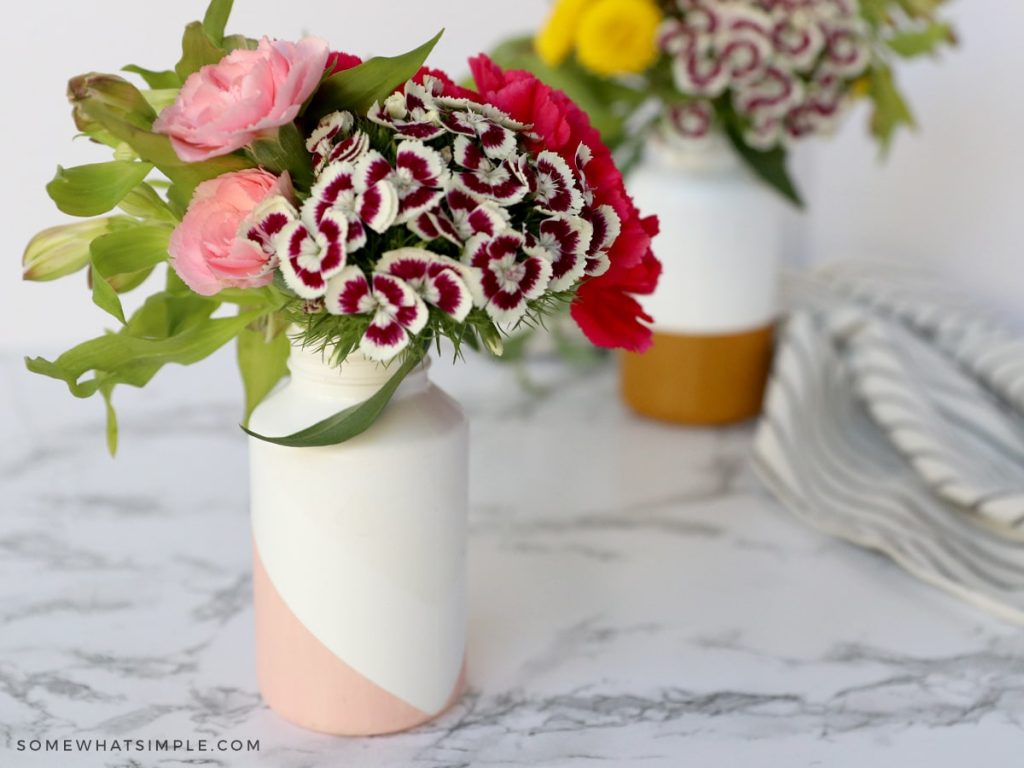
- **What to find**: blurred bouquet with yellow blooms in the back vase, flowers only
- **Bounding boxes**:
[495,0,955,204]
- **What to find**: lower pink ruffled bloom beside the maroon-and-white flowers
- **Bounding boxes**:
[168,169,292,296]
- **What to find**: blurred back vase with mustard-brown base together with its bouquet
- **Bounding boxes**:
[495,0,954,424]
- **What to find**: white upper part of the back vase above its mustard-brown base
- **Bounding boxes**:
[630,140,785,335]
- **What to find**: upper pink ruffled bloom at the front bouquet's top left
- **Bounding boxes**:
[153,37,328,163]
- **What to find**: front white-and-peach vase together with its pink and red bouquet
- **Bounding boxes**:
[25,0,658,733]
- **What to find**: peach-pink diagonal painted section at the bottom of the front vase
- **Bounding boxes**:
[253,544,466,736]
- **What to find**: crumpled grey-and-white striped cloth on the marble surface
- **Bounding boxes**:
[755,264,1024,623]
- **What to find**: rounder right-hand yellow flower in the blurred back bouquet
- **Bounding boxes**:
[575,0,662,77]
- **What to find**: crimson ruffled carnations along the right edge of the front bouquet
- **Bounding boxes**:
[469,55,662,352]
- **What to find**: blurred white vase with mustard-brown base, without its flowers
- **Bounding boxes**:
[622,136,784,424]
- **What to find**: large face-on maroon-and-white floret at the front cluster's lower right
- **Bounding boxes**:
[463,229,552,325]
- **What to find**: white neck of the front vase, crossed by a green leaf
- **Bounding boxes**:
[288,342,430,399]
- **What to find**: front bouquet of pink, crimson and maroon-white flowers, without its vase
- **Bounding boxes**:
[24,0,658,452]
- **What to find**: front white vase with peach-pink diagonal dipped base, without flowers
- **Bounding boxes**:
[250,346,468,735]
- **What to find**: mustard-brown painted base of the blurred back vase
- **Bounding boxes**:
[622,325,774,426]
